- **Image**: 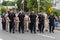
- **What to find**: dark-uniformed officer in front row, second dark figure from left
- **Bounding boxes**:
[8,10,15,33]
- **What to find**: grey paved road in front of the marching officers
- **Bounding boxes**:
[0,22,60,40]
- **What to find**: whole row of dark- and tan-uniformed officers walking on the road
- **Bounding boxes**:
[1,10,57,33]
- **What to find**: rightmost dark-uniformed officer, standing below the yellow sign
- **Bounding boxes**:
[48,13,56,33]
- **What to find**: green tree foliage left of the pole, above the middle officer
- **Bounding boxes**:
[26,0,38,12]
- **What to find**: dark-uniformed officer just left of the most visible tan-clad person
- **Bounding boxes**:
[18,9,25,33]
